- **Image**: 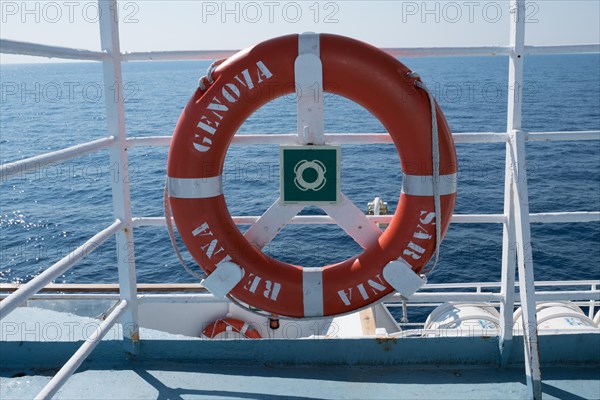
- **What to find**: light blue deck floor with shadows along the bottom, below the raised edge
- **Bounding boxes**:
[0,361,600,400]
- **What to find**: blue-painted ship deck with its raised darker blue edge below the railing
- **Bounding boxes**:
[0,307,600,400]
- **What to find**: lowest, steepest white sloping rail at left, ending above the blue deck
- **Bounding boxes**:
[35,300,128,400]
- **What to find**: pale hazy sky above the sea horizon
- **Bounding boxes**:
[0,0,600,62]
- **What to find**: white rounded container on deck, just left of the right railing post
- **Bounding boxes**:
[424,302,500,336]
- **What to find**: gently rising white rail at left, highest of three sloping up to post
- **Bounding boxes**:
[0,136,115,181]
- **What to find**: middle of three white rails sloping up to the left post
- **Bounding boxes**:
[0,220,123,319]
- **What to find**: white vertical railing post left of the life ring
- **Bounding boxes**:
[98,0,139,354]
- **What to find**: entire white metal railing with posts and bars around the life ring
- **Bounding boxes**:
[0,0,600,398]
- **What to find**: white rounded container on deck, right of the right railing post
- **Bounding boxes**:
[513,301,597,335]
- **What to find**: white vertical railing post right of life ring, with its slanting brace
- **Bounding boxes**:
[502,0,542,399]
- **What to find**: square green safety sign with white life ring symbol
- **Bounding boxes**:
[280,146,340,204]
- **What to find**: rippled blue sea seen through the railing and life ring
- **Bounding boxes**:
[0,55,600,306]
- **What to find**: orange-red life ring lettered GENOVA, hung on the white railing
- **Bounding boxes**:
[167,34,457,318]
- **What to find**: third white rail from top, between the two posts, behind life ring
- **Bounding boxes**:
[133,214,505,228]
